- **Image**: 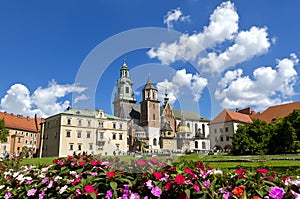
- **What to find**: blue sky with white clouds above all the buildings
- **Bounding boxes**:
[0,0,300,119]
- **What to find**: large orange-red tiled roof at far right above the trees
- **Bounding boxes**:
[251,102,300,122]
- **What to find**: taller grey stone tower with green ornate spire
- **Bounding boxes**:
[113,59,136,118]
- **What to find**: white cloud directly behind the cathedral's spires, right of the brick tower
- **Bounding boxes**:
[157,69,208,104]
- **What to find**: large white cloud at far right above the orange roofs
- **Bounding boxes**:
[215,54,299,110]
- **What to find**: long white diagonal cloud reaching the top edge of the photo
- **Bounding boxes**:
[147,1,239,64]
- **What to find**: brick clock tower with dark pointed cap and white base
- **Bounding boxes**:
[140,75,161,149]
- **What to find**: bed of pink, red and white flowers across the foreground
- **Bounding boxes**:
[0,156,300,199]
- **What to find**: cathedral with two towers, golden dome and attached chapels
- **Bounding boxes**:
[113,60,210,153]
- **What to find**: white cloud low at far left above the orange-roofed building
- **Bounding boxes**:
[1,81,86,117]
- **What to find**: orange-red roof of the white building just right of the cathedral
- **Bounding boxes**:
[210,110,252,124]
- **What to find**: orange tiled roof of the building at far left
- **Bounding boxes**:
[0,112,43,132]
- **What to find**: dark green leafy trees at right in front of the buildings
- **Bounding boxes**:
[232,110,300,155]
